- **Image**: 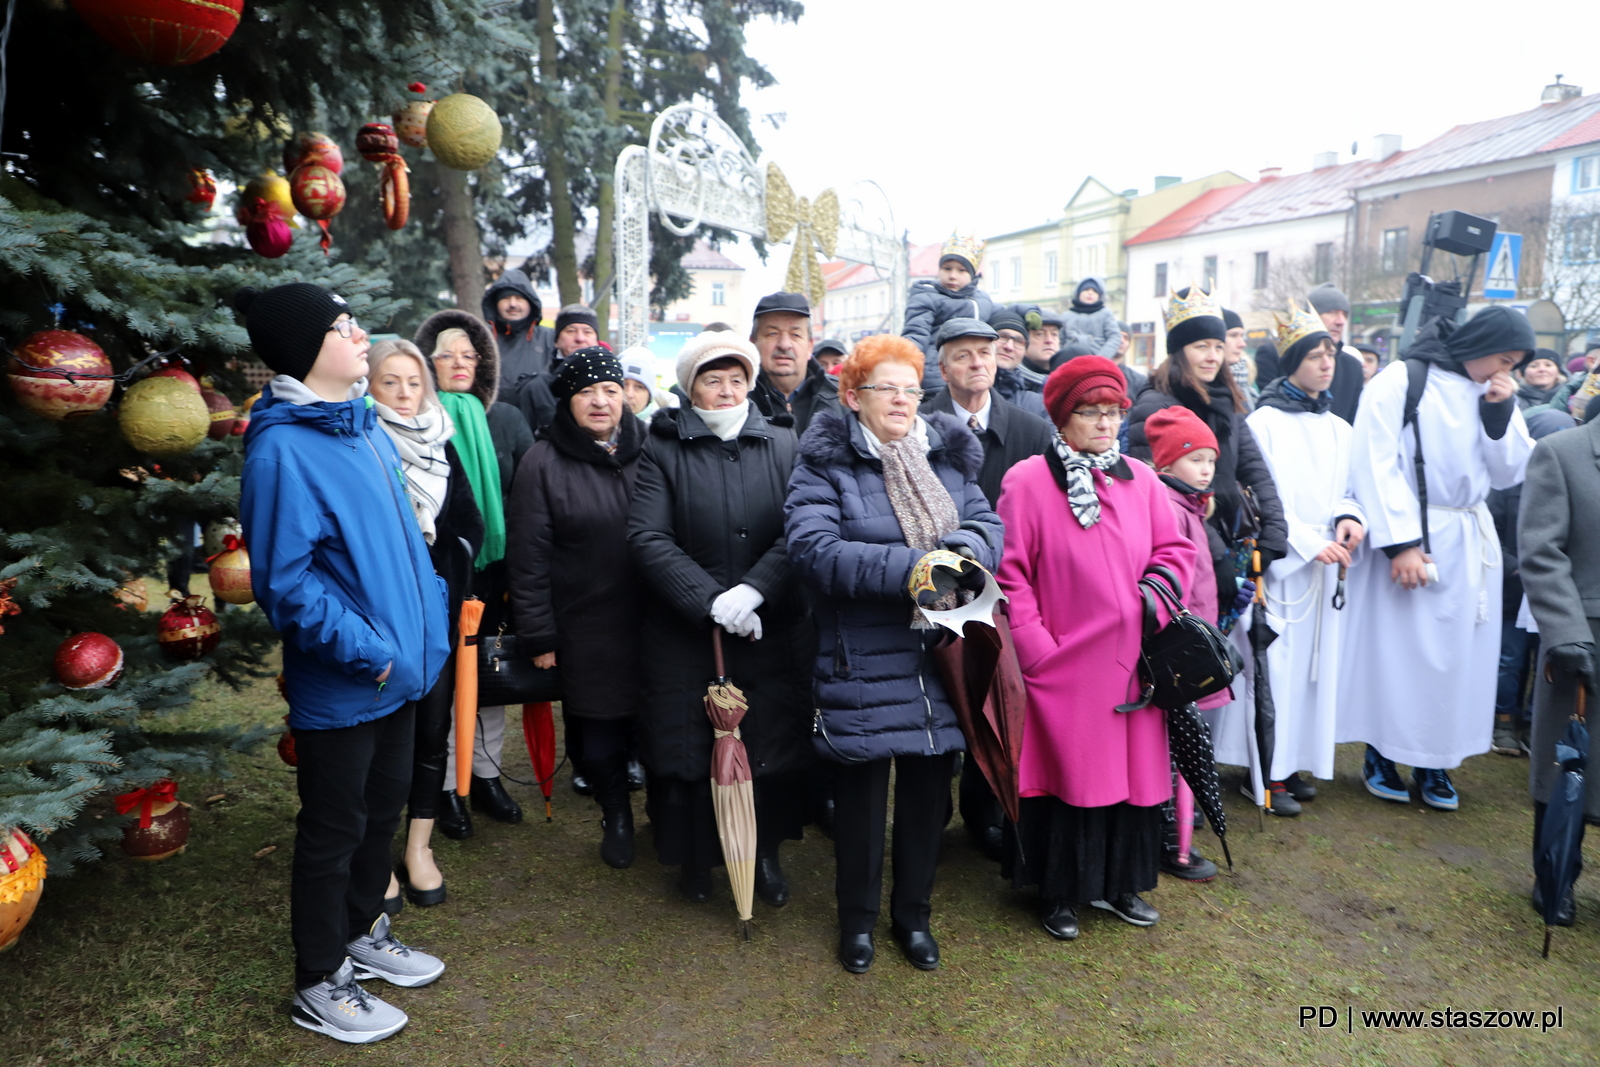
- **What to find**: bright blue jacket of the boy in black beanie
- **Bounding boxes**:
[238,376,450,729]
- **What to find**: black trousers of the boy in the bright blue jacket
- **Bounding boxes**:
[290,704,416,989]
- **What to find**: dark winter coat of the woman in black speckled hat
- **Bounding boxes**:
[506,405,645,720]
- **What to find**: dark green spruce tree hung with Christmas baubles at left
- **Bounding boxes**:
[0,0,530,875]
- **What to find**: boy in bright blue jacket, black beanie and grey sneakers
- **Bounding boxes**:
[234,283,450,1045]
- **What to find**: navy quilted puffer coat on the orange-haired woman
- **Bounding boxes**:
[784,408,1005,761]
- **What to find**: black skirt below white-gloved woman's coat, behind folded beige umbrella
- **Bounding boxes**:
[645,774,808,869]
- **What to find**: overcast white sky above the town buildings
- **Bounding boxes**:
[725,0,1600,293]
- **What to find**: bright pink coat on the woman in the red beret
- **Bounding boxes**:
[997,456,1197,808]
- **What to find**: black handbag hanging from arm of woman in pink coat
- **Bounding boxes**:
[1117,568,1245,712]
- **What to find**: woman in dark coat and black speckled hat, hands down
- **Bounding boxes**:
[506,347,645,867]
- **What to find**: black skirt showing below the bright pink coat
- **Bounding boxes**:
[1002,797,1162,904]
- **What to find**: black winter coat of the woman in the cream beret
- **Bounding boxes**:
[627,406,816,782]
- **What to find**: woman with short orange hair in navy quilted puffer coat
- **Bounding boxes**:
[784,336,1005,973]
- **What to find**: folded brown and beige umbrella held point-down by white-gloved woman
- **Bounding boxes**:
[706,627,755,939]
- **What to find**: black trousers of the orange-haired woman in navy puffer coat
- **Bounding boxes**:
[834,752,955,934]
